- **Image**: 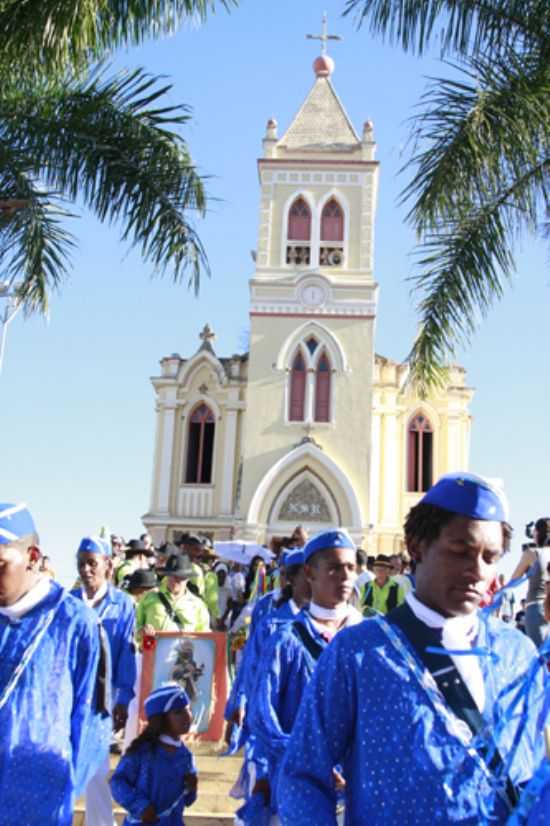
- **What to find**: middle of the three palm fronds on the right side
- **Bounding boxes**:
[402,54,550,235]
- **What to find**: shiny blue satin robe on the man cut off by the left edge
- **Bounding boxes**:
[0,582,112,826]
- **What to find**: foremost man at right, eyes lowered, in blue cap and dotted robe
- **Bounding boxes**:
[277,474,544,826]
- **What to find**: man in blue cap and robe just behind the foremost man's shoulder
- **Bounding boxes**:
[249,531,362,824]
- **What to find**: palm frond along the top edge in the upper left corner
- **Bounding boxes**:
[0,0,238,75]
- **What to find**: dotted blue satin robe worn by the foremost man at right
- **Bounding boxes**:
[278,619,544,826]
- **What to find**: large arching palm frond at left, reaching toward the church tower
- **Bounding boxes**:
[0,70,209,306]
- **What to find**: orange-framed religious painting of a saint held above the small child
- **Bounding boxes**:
[140,631,228,740]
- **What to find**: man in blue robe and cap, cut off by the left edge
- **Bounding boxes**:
[0,504,111,826]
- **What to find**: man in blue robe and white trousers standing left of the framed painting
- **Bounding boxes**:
[72,537,137,826]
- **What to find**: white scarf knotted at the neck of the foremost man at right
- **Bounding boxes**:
[406,592,485,711]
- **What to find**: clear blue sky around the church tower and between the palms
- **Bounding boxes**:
[0,0,550,582]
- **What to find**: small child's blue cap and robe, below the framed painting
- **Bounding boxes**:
[111,684,197,826]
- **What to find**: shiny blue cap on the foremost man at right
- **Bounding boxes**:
[419,472,508,522]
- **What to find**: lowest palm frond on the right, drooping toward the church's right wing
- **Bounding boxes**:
[408,157,550,395]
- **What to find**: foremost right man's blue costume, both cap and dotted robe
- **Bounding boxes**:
[277,474,548,826]
